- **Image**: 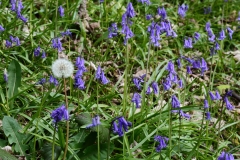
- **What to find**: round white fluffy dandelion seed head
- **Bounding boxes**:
[52,58,74,78]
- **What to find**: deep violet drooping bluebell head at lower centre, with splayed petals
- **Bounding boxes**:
[113,116,132,137]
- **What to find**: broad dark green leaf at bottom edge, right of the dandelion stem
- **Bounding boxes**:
[80,144,114,160]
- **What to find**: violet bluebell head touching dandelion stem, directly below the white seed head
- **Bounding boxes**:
[51,105,69,125]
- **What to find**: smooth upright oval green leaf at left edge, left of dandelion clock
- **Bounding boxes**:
[7,60,21,105]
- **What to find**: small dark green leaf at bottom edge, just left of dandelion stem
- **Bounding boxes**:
[41,143,62,160]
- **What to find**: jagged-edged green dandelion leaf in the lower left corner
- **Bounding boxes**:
[2,116,28,155]
